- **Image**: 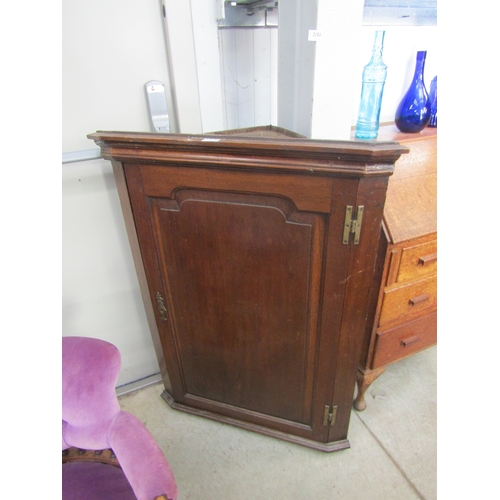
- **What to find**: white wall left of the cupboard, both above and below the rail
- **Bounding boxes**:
[62,0,173,385]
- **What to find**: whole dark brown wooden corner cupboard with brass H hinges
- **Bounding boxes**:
[89,126,408,451]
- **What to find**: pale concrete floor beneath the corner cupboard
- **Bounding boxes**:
[119,347,437,500]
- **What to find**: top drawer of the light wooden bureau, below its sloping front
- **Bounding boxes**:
[396,240,437,283]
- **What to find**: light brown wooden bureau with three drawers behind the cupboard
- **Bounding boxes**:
[354,125,437,410]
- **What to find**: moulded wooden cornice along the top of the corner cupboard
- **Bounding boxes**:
[87,131,409,176]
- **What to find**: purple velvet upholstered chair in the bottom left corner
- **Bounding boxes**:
[62,337,177,500]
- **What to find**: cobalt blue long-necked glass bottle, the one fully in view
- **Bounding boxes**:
[394,50,431,133]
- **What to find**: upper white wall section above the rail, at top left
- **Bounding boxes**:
[62,0,172,151]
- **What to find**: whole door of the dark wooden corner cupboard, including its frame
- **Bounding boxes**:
[125,165,349,442]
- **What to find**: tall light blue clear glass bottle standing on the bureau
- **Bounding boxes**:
[355,31,387,139]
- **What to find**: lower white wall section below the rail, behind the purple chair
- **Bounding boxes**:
[62,159,159,385]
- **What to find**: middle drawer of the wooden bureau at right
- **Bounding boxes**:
[379,276,437,326]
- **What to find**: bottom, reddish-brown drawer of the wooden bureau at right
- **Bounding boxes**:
[371,312,437,370]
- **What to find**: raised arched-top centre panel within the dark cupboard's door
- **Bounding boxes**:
[150,190,324,423]
